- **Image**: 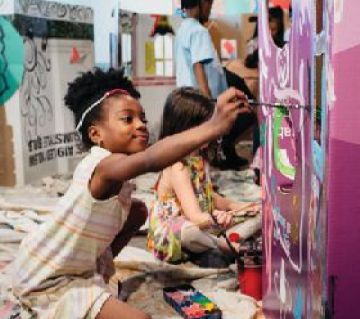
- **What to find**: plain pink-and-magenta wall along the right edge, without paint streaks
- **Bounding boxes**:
[328,0,360,319]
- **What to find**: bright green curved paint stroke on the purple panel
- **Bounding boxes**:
[273,107,296,179]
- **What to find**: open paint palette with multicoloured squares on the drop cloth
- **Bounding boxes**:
[163,285,222,319]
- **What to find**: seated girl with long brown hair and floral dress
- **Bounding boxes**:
[148,87,260,262]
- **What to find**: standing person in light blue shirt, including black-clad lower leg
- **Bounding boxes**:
[175,0,256,169]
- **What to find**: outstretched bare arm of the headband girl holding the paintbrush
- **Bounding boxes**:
[90,88,250,199]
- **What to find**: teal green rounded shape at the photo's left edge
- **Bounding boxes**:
[0,17,24,105]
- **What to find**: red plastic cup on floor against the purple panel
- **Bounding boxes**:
[238,265,262,300]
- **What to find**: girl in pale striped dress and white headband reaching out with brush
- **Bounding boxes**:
[13,70,248,319]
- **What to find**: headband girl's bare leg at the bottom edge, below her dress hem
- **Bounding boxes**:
[96,297,151,319]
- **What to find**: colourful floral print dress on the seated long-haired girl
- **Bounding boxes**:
[147,155,214,263]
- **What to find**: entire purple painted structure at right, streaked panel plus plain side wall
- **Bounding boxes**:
[259,0,360,319]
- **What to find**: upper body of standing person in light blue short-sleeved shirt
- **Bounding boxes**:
[175,0,227,98]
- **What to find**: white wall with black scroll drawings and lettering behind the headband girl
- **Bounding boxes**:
[5,38,94,185]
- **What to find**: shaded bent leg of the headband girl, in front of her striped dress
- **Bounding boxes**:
[111,199,148,257]
